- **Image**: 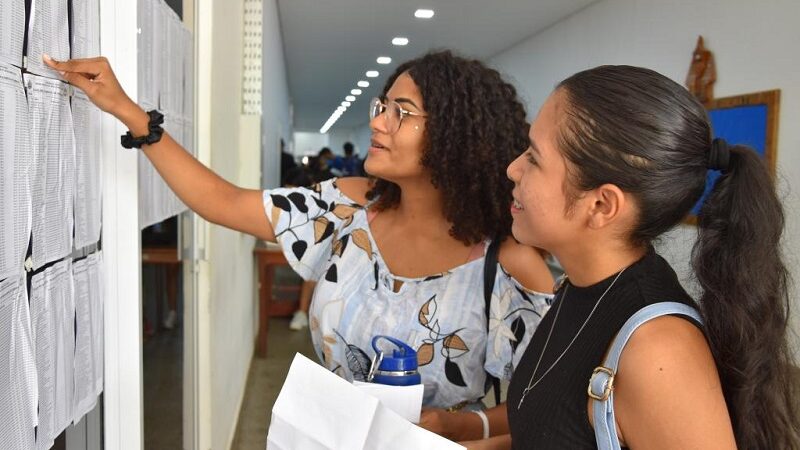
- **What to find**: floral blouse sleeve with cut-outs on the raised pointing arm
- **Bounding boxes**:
[263,179,363,281]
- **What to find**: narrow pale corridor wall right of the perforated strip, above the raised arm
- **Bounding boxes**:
[261,0,292,188]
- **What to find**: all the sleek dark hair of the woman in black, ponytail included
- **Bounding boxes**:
[559,66,800,449]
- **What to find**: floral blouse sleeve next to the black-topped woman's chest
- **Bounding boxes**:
[484,264,553,380]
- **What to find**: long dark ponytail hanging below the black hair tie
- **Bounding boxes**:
[692,146,800,449]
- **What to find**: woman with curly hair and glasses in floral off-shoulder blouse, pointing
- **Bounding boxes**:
[45,51,553,440]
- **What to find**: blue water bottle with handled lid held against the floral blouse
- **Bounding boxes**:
[370,335,422,386]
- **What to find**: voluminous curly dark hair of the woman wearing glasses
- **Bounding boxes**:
[367,51,528,245]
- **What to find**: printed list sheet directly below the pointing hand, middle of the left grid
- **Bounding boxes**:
[24,74,75,269]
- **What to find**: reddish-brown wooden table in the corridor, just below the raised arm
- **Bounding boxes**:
[253,241,297,358]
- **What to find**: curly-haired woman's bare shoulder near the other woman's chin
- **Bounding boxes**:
[497,237,554,293]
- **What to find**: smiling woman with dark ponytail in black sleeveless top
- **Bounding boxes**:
[462,66,800,450]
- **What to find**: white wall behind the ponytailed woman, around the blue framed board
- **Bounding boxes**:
[491,0,800,356]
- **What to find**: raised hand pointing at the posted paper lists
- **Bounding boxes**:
[42,55,141,124]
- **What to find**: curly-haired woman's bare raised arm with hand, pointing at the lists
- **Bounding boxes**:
[44,56,275,241]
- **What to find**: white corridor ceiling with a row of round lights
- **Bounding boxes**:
[278,0,594,131]
